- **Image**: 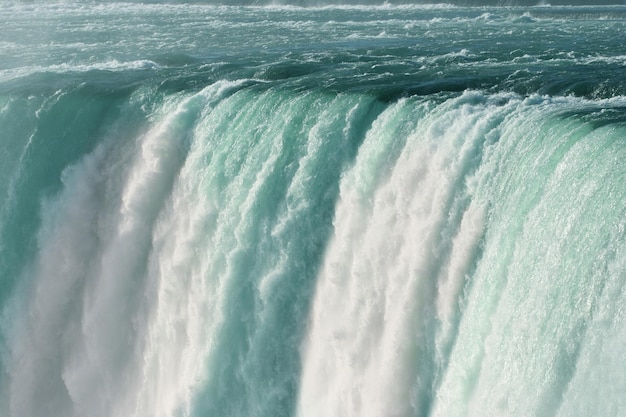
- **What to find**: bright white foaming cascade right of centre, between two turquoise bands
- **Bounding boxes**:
[298,93,510,416]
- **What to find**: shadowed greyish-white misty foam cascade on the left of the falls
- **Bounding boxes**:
[1,83,238,417]
